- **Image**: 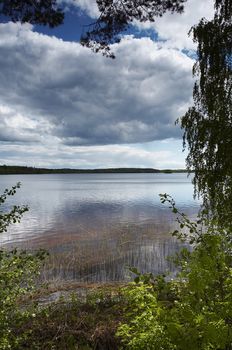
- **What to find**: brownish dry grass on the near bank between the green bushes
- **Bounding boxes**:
[15,286,126,350]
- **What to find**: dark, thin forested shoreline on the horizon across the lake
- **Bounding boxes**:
[0,165,188,175]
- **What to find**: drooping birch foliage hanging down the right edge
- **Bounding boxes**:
[181,0,232,225]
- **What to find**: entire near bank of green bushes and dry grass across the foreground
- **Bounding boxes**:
[0,185,232,350]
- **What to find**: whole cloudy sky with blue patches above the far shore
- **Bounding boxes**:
[0,0,213,169]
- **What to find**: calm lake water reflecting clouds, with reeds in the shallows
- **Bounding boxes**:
[0,174,200,282]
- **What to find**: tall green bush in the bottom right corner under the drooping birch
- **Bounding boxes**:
[164,233,232,350]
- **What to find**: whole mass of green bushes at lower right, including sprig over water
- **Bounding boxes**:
[117,197,232,350]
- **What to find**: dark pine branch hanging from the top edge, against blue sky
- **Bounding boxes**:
[81,0,187,58]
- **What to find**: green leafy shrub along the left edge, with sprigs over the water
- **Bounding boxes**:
[0,183,46,350]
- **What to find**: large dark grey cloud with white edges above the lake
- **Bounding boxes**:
[0,23,192,146]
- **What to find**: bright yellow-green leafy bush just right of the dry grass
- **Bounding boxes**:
[117,282,175,350]
